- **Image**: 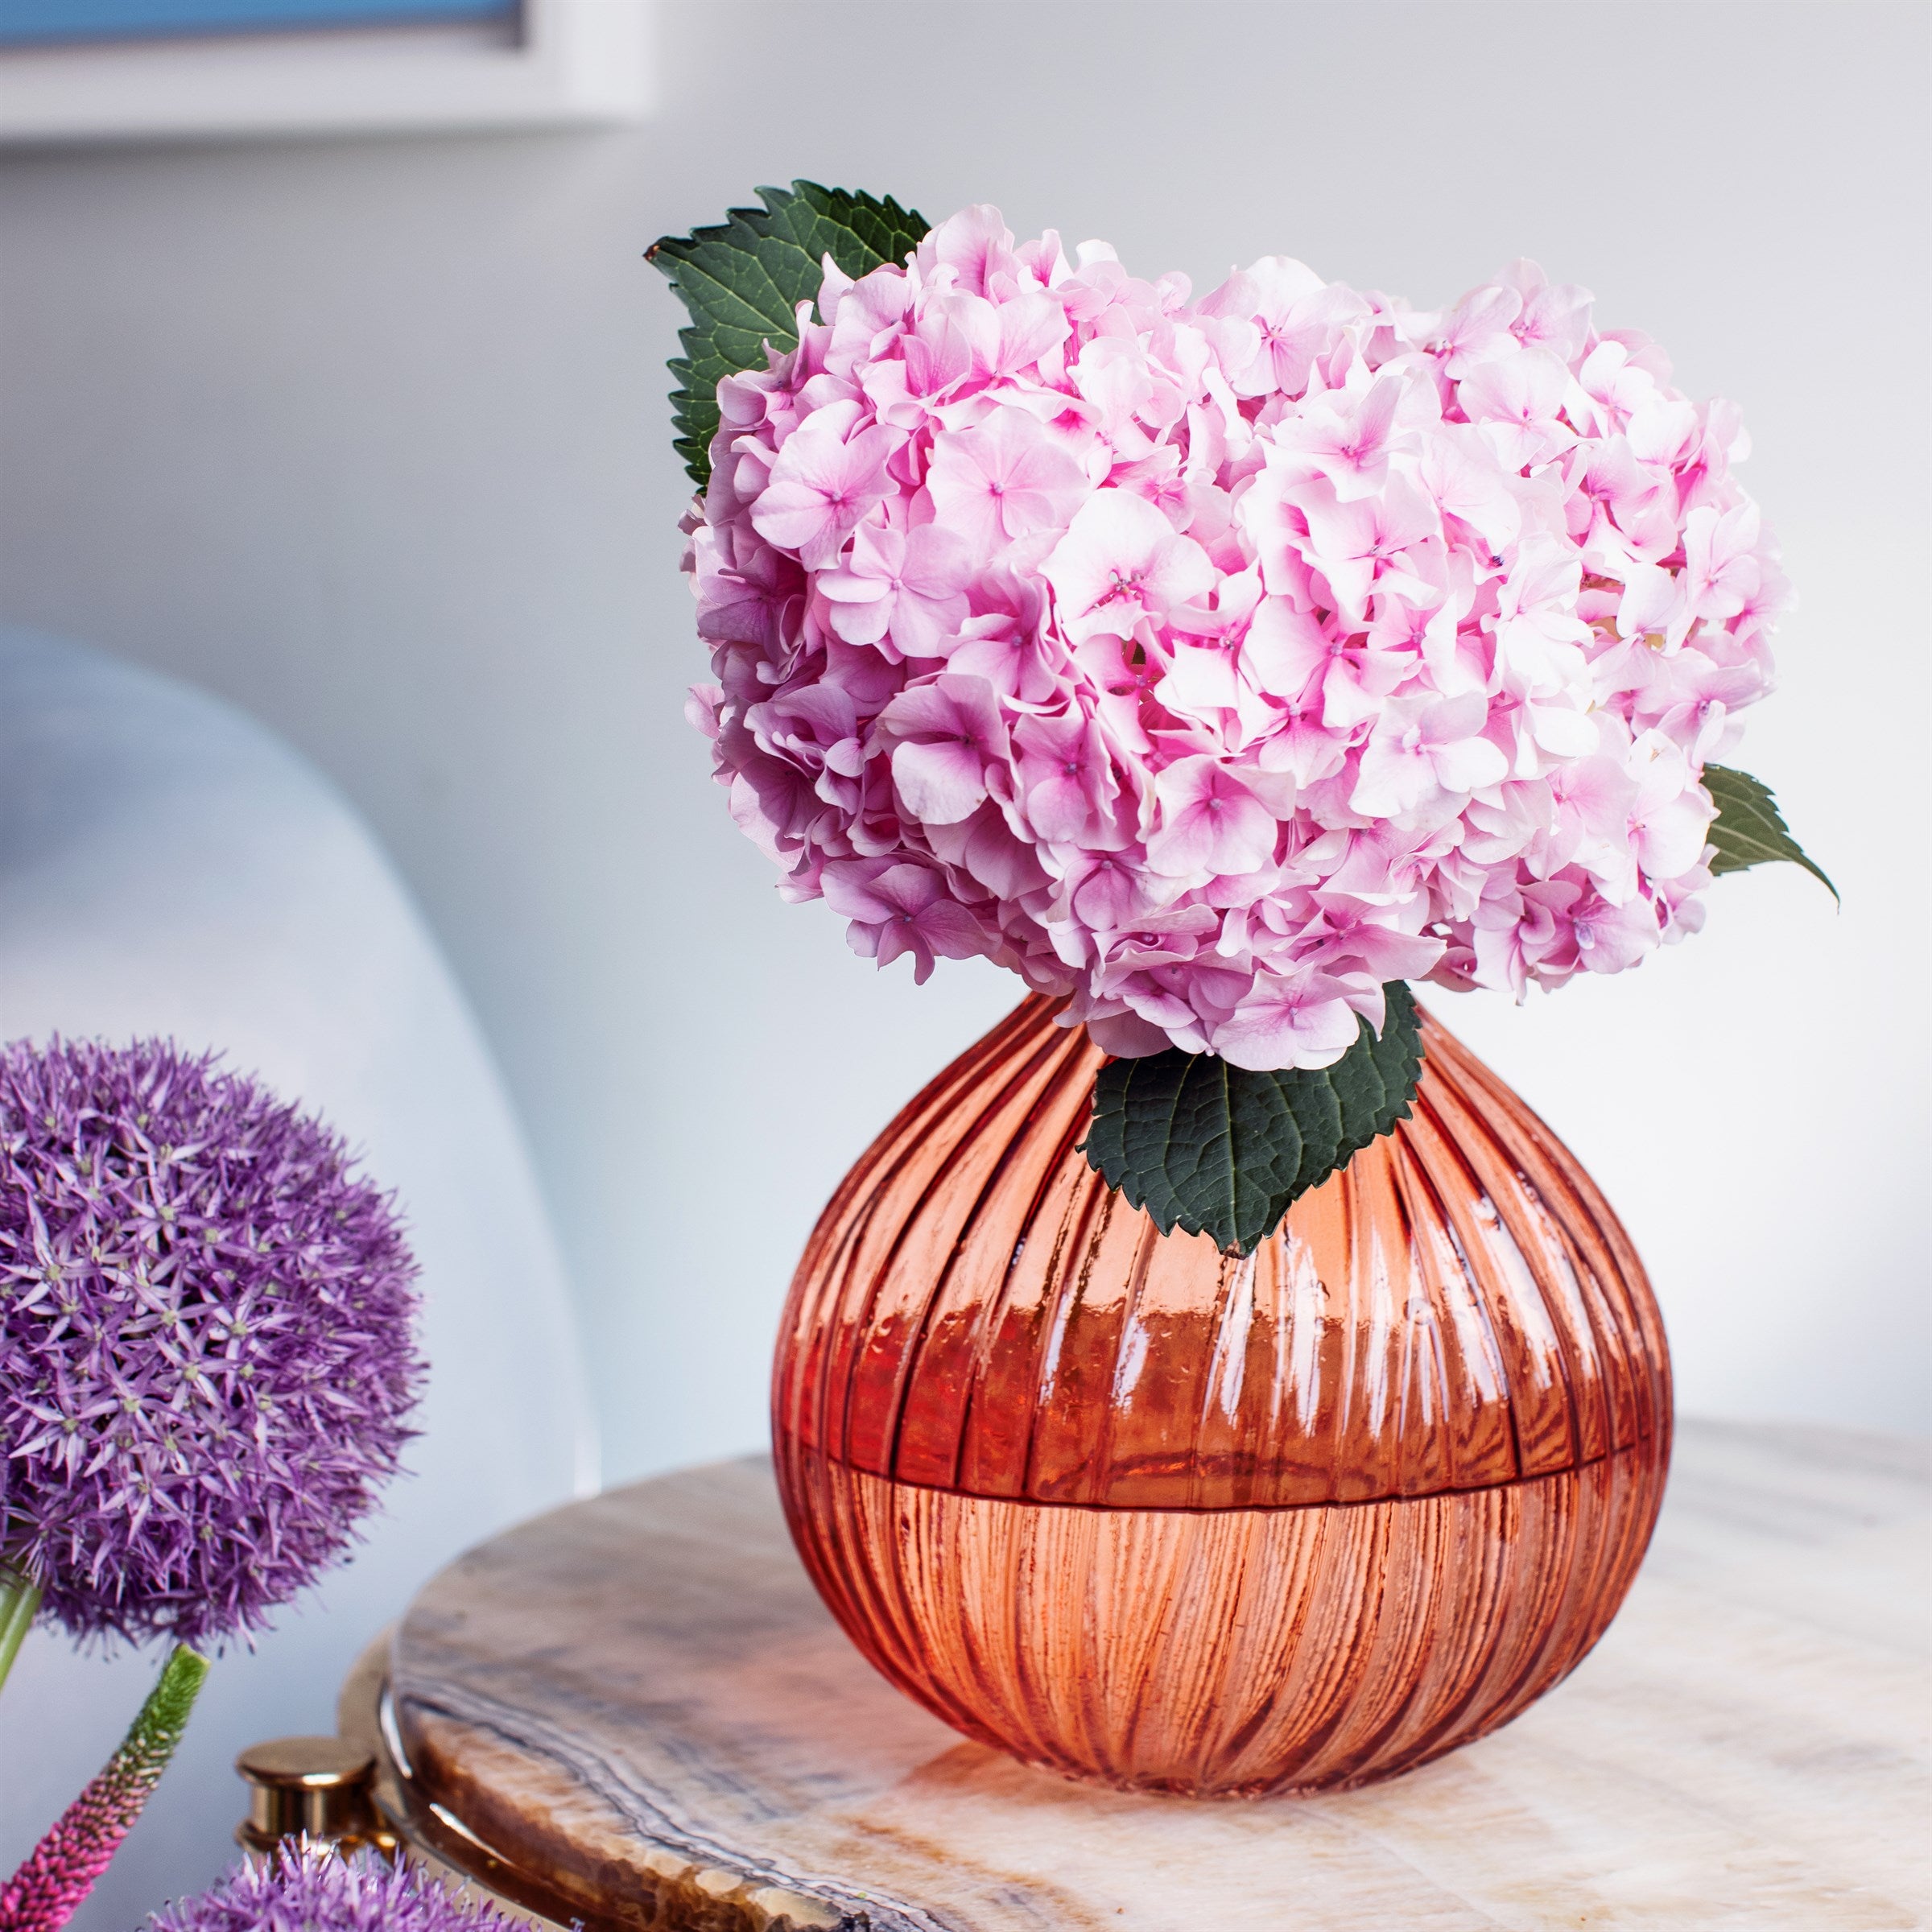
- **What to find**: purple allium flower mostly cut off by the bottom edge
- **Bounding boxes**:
[147,1841,522,1932]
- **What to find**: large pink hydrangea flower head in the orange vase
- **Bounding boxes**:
[687,208,1785,1068]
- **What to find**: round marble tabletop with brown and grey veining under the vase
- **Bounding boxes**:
[390,1422,1932,1932]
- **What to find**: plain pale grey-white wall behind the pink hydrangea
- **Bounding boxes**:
[0,0,1932,1476]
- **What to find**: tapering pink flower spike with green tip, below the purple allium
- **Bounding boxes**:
[0,1644,208,1932]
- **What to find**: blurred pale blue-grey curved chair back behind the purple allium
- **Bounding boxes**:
[0,632,595,1932]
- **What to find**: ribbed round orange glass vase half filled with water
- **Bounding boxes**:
[773,999,1671,1795]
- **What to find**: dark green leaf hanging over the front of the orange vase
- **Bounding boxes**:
[1082,981,1422,1254]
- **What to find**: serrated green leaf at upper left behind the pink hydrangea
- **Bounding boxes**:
[646,182,927,489]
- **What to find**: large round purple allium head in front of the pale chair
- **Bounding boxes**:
[0,1039,421,1646]
